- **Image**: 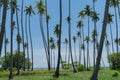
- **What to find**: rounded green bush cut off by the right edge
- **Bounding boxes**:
[108,53,120,70]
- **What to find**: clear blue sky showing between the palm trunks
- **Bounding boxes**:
[3,0,118,68]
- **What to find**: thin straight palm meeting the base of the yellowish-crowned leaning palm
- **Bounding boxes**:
[45,0,50,70]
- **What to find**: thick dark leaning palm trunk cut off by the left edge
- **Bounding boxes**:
[0,0,8,57]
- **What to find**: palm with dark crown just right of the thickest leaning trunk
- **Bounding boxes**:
[107,13,114,53]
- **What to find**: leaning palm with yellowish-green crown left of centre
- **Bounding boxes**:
[36,0,50,70]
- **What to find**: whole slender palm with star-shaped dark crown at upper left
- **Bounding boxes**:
[25,5,35,70]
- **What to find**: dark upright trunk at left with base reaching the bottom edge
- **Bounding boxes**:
[9,0,14,80]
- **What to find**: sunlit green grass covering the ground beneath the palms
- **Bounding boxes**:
[0,69,120,80]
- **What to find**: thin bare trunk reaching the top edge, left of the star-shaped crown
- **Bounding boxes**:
[21,0,25,71]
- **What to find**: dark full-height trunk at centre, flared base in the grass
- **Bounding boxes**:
[54,0,62,78]
